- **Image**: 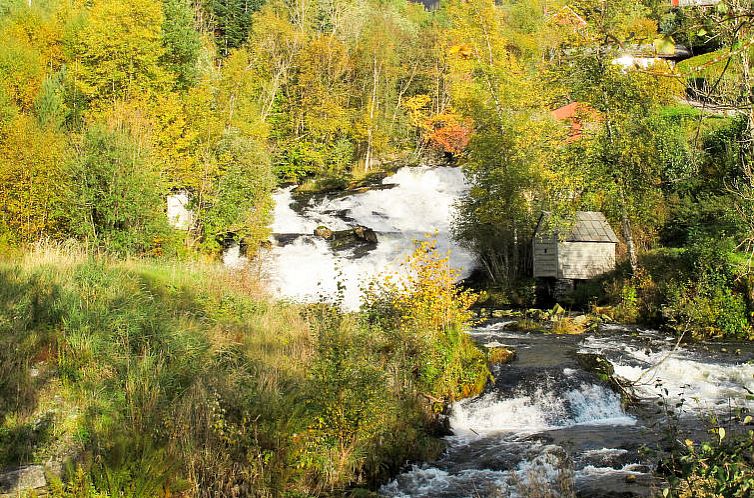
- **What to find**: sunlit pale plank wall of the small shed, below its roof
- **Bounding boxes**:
[556,242,615,280]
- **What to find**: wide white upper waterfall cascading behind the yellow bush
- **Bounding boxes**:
[267,166,475,309]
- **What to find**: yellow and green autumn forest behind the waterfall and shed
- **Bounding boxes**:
[0,0,754,335]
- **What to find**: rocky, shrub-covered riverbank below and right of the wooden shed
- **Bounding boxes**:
[465,240,754,340]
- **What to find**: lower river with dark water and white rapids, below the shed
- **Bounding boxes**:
[381,322,754,497]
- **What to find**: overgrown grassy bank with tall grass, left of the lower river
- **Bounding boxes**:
[0,243,488,496]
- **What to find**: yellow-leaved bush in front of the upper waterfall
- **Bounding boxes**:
[362,239,490,401]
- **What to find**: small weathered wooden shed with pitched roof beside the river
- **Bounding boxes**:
[532,211,618,299]
